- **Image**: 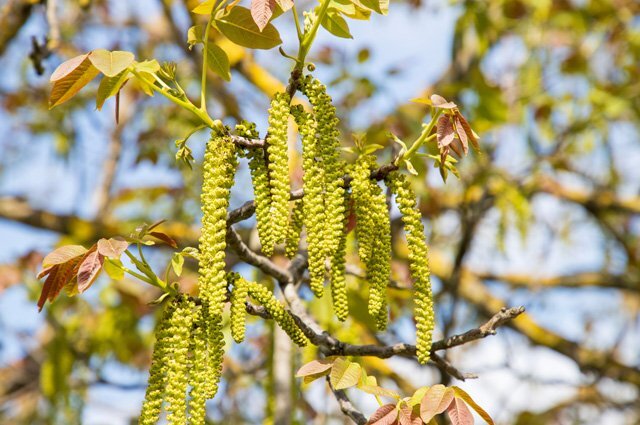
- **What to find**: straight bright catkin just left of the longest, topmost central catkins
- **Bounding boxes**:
[267,93,291,244]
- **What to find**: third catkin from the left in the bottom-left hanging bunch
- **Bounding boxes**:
[189,306,209,425]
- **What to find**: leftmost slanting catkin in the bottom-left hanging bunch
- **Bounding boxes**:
[138,303,175,425]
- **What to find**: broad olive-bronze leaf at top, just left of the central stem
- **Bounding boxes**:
[215,6,282,49]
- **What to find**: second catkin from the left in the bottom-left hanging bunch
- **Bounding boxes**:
[164,297,193,425]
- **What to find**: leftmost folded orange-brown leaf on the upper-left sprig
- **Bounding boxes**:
[49,53,100,109]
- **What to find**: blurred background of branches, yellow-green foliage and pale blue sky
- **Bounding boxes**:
[0,0,640,425]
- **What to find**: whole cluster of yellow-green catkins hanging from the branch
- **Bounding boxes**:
[140,76,434,424]
